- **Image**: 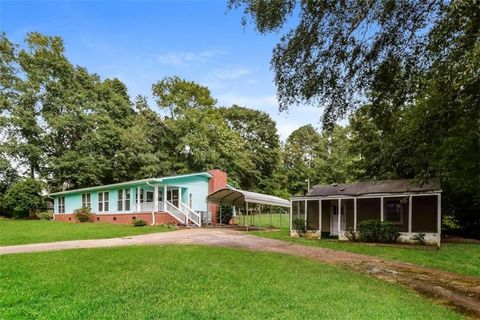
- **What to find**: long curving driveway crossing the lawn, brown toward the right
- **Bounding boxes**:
[0,228,480,319]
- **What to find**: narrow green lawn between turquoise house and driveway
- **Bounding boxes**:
[0,219,171,246]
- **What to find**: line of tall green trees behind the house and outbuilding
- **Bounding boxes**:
[0,33,480,235]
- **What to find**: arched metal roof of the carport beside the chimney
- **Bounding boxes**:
[207,188,290,207]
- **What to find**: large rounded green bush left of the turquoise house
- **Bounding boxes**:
[2,178,46,218]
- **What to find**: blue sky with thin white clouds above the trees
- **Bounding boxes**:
[0,0,321,139]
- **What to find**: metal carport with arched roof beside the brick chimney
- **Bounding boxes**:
[207,188,290,231]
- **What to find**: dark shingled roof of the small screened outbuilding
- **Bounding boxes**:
[306,179,442,197]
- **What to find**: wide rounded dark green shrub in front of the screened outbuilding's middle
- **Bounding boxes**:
[357,220,400,242]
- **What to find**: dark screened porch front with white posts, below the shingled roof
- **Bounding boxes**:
[290,193,441,245]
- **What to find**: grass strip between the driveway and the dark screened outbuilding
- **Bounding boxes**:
[250,229,480,276]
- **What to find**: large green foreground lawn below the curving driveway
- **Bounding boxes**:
[0,246,461,319]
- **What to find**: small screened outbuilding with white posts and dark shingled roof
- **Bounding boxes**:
[290,180,442,245]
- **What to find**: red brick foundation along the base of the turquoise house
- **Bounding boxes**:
[53,212,178,225]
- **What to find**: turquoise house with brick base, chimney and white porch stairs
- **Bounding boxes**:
[50,170,227,226]
